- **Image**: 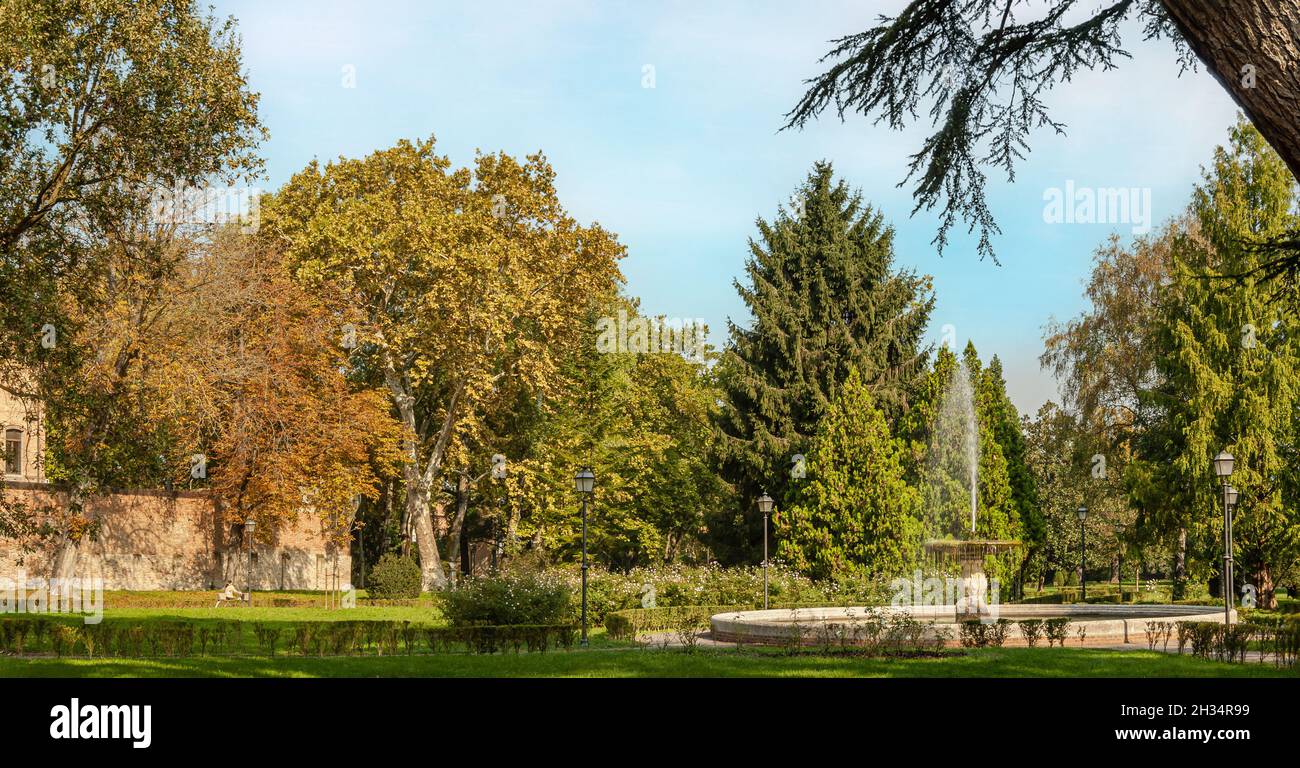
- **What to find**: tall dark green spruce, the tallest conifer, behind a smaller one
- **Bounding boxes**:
[710,162,933,561]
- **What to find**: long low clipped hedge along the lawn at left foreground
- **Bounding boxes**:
[0,617,577,658]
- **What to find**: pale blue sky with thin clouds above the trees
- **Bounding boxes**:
[215,0,1236,415]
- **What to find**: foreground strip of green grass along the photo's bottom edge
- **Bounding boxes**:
[0,646,1300,677]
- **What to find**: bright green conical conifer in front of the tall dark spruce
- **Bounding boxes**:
[774,370,920,578]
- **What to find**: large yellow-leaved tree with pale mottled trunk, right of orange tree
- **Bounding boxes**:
[263,139,623,587]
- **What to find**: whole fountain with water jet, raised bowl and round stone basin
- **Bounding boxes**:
[710,365,1223,646]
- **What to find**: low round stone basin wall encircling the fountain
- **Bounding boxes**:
[710,604,1236,646]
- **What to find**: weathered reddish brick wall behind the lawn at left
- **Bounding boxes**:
[0,482,352,590]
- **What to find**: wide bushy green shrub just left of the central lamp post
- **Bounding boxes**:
[443,573,573,626]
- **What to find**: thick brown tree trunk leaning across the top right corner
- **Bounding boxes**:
[1161,0,1300,178]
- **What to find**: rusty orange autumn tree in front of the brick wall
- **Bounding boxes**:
[188,229,404,544]
